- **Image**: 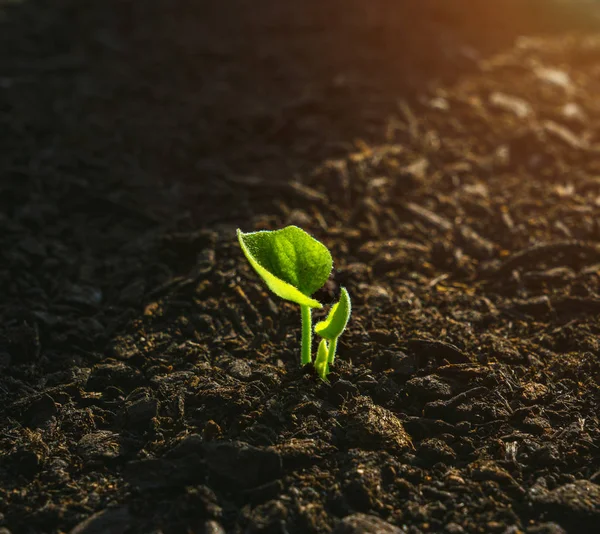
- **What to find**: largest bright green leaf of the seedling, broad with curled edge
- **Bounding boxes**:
[237,226,333,308]
